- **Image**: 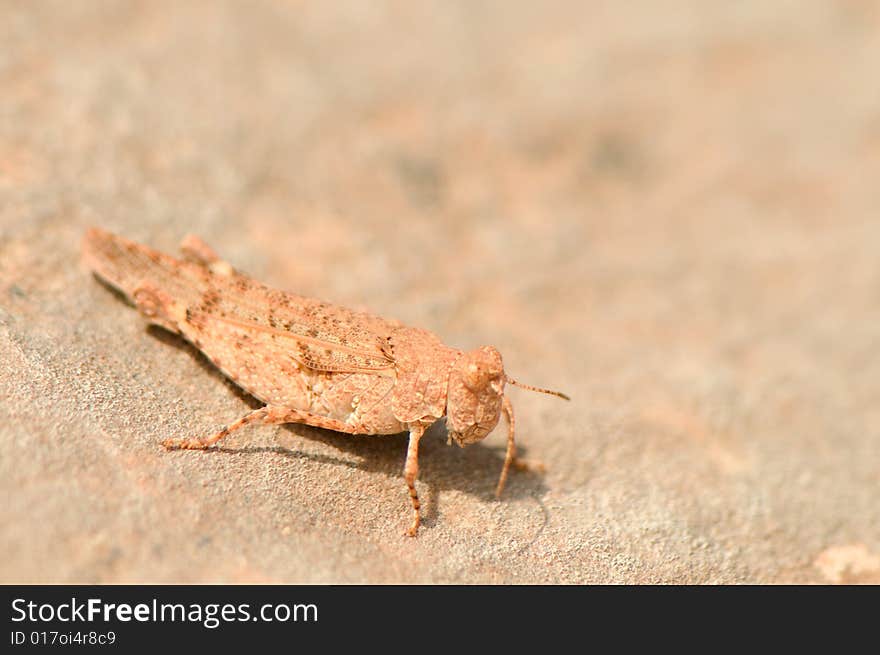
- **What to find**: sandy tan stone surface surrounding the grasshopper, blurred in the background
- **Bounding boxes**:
[0,0,880,583]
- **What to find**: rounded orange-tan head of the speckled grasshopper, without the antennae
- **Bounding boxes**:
[446,346,506,446]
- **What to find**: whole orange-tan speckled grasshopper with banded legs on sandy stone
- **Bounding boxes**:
[83,228,568,536]
